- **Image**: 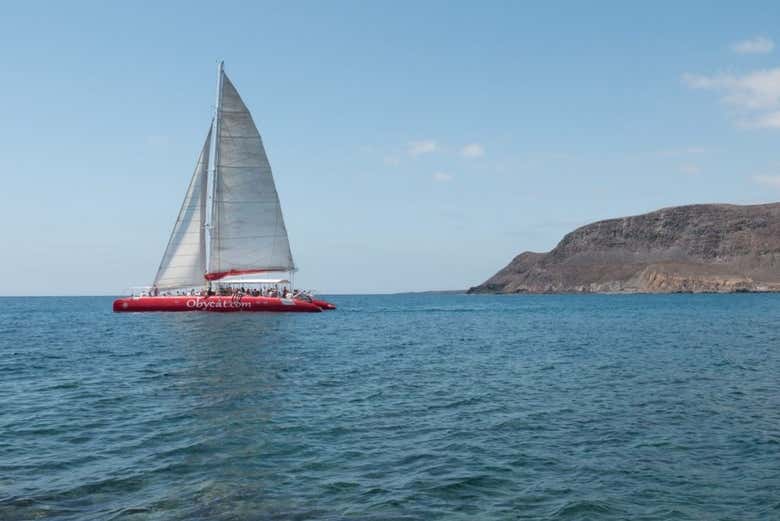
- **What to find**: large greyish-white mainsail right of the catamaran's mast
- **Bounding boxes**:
[208,73,294,277]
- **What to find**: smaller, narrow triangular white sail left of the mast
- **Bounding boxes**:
[154,129,211,289]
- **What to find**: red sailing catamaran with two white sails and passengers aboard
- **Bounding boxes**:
[114,62,335,312]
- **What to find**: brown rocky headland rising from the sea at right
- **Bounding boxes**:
[469,203,780,293]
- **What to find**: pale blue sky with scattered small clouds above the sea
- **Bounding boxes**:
[0,1,780,295]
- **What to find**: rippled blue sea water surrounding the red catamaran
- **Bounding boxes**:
[0,294,780,521]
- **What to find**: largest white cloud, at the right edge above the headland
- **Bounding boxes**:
[682,67,780,128]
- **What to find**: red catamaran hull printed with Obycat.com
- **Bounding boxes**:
[114,296,324,313]
